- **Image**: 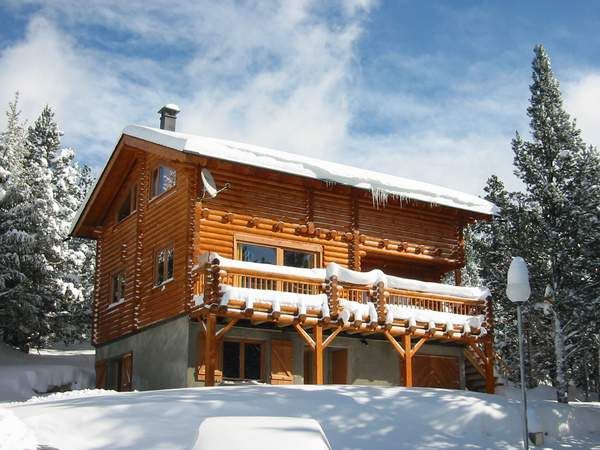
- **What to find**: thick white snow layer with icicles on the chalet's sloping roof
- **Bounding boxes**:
[123,125,498,215]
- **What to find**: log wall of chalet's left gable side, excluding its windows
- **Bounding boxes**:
[94,152,196,344]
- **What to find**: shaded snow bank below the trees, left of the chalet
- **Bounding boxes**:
[0,343,95,403]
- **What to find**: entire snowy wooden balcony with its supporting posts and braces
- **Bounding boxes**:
[191,253,495,393]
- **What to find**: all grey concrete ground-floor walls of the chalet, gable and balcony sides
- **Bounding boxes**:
[96,317,465,390]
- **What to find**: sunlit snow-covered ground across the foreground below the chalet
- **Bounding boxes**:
[0,385,600,450]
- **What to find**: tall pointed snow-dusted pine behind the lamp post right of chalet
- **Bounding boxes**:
[476,46,598,402]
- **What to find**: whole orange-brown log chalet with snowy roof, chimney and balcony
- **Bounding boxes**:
[72,105,495,393]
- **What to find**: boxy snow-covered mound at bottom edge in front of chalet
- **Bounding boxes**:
[192,416,331,450]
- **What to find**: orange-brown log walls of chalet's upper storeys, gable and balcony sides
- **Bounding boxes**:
[93,143,474,344]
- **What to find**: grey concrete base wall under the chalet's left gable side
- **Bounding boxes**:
[96,316,190,390]
